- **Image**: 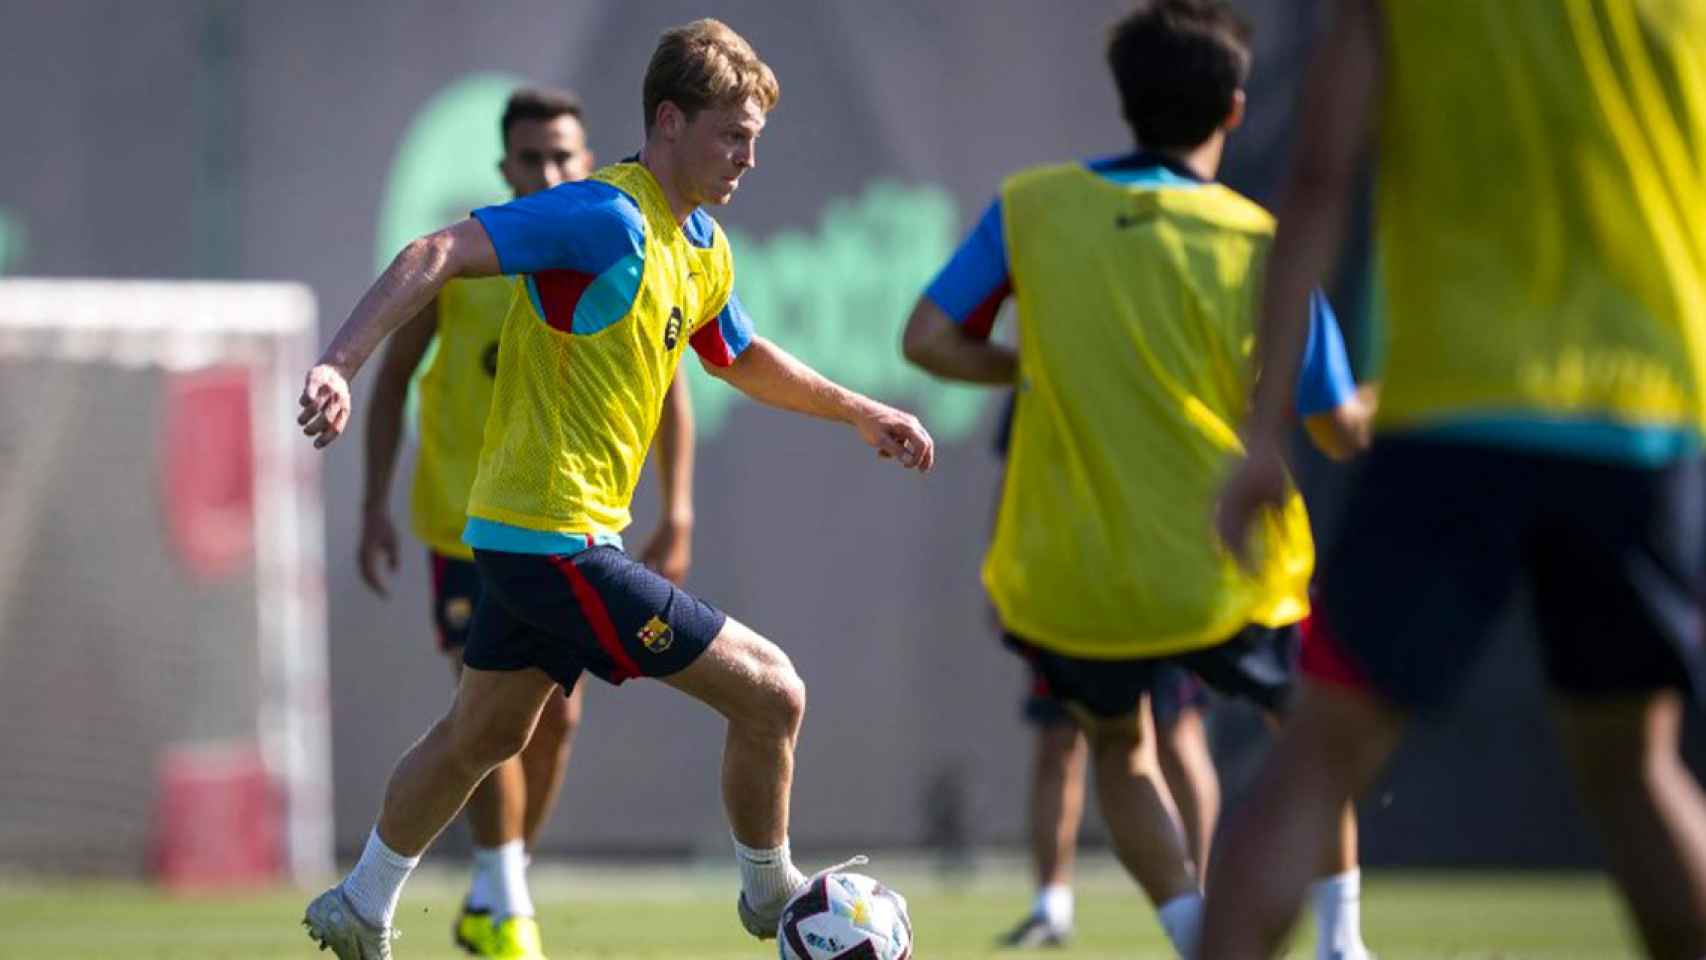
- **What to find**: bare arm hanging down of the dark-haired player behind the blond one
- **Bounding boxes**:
[355,300,438,597]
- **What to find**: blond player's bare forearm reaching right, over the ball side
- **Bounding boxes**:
[705,338,937,472]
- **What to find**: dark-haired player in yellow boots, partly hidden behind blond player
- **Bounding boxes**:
[358,87,693,957]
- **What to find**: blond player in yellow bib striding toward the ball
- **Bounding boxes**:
[300,20,935,960]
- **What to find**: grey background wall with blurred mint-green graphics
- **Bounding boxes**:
[0,0,1617,865]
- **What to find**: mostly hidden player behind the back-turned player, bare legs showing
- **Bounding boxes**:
[995,397,1220,948]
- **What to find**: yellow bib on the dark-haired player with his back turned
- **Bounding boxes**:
[983,165,1314,658]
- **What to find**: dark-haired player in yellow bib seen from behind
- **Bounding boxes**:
[904,0,1367,960]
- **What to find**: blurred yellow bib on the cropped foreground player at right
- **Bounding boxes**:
[1378,0,1706,428]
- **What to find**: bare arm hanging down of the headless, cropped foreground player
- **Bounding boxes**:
[1216,0,1380,563]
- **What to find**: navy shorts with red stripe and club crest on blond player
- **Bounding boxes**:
[462,546,727,691]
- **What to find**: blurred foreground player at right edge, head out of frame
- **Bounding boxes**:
[1206,0,1706,960]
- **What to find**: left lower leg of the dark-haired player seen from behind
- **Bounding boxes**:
[1075,697,1203,957]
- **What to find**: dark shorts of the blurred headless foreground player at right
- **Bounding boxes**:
[1303,437,1706,711]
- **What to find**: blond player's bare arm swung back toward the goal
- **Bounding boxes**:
[297,218,502,447]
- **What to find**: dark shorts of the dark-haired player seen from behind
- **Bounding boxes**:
[1005,626,1298,720]
